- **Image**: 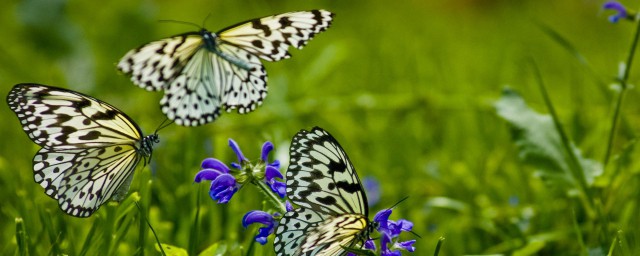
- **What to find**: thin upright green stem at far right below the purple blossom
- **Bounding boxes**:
[602,13,640,167]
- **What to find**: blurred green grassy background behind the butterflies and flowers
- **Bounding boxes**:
[0,0,640,255]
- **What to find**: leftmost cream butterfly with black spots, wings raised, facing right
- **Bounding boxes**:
[7,84,159,217]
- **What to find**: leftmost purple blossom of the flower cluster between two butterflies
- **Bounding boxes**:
[194,158,240,204]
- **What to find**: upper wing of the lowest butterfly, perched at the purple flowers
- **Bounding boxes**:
[286,129,368,216]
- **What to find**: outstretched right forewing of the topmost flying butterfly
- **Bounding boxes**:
[217,10,334,61]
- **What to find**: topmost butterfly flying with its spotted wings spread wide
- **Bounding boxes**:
[118,10,333,126]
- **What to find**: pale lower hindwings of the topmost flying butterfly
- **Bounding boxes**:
[160,43,267,126]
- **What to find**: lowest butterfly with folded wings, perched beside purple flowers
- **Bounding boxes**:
[274,127,376,255]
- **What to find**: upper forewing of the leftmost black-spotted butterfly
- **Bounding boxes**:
[7,84,141,149]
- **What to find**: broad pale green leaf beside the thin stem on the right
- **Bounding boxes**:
[495,89,602,189]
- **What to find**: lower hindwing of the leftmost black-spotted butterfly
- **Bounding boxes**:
[33,145,140,217]
